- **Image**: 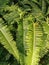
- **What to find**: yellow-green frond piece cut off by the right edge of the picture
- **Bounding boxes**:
[42,21,49,49]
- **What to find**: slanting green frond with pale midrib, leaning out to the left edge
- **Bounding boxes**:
[0,23,19,61]
